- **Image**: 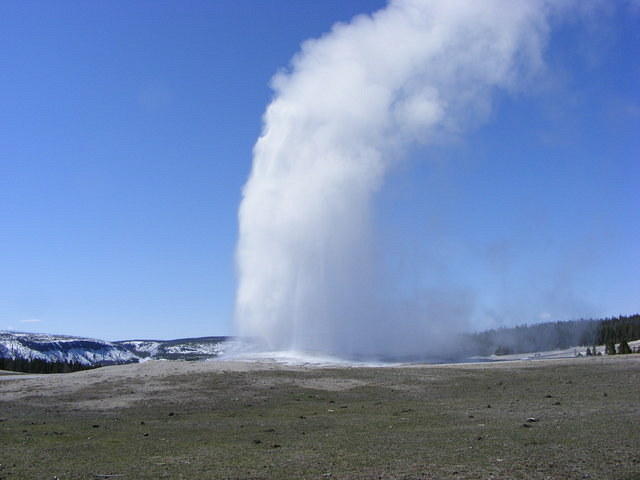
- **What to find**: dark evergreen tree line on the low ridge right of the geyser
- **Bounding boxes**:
[465,314,640,355]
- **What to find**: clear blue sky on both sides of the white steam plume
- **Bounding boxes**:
[0,0,640,339]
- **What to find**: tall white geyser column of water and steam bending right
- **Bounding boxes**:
[236,0,551,357]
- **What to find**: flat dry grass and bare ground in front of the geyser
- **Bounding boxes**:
[0,355,640,480]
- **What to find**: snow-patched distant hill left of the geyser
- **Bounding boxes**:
[0,331,227,365]
